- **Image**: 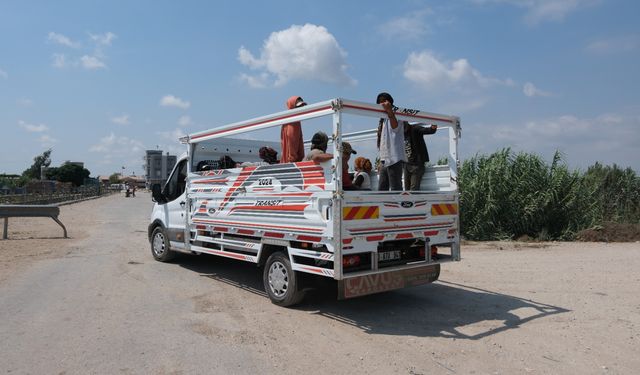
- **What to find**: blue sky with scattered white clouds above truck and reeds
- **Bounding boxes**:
[0,0,640,176]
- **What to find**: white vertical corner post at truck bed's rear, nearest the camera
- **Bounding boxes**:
[333,103,343,280]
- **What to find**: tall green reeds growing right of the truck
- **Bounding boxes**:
[459,148,640,240]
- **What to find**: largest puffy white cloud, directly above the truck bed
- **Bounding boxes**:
[238,24,356,87]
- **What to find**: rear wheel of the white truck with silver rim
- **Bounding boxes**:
[262,251,304,307]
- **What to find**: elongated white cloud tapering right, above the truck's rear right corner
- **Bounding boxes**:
[404,51,514,90]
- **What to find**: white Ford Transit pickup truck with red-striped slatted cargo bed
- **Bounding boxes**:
[148,99,460,306]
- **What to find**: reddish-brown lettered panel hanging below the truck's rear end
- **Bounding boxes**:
[338,264,440,299]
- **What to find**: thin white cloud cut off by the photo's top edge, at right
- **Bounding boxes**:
[473,0,600,25]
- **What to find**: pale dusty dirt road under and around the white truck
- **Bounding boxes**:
[0,193,640,374]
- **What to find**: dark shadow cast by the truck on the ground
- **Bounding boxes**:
[179,257,570,340]
